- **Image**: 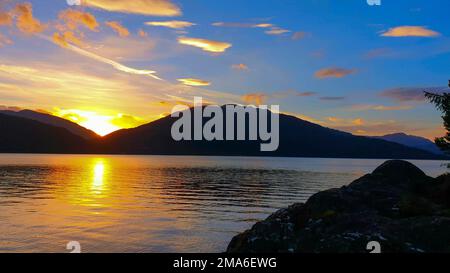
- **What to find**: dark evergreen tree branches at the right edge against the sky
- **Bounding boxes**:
[425,81,450,154]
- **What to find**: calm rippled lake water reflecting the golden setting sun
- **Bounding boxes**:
[0,154,445,252]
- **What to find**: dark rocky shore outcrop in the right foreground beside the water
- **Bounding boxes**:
[227,160,450,253]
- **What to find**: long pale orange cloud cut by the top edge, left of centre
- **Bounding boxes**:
[82,0,181,16]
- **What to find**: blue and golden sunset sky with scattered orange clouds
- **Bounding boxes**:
[0,0,450,136]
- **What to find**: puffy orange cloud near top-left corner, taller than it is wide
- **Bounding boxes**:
[13,3,45,34]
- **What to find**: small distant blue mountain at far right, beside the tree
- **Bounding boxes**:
[373,133,443,155]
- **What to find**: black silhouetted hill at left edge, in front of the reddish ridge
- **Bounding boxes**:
[0,114,88,153]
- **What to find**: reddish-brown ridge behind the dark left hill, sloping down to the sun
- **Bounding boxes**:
[0,110,99,139]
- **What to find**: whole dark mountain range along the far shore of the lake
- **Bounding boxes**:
[0,110,445,159]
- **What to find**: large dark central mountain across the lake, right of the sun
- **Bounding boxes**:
[97,105,443,159]
